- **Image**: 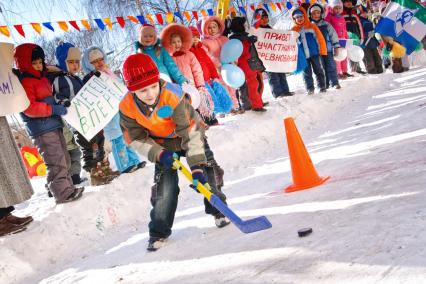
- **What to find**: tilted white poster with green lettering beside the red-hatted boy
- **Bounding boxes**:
[64,73,128,140]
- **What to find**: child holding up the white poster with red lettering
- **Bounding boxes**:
[253,8,294,98]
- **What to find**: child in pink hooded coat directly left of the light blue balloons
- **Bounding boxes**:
[201,16,240,113]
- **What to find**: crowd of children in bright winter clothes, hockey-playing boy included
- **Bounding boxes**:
[6,0,422,244]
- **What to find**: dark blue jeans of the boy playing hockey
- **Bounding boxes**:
[148,141,226,238]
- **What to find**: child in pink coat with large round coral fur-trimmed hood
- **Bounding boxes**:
[160,24,214,119]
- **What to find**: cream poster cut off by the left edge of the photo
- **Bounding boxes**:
[0,42,30,116]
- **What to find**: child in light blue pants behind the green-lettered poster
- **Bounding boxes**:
[83,46,145,178]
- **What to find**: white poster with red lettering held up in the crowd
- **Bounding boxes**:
[250,28,299,73]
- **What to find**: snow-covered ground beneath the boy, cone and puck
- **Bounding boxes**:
[0,52,426,283]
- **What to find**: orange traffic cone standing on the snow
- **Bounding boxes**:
[284,117,330,193]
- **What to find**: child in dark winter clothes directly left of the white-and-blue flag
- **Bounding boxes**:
[359,6,383,74]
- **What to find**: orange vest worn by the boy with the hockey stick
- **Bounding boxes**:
[120,82,195,138]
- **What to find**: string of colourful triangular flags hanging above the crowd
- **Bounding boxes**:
[0,0,326,38]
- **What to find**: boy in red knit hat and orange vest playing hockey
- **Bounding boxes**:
[120,54,229,251]
